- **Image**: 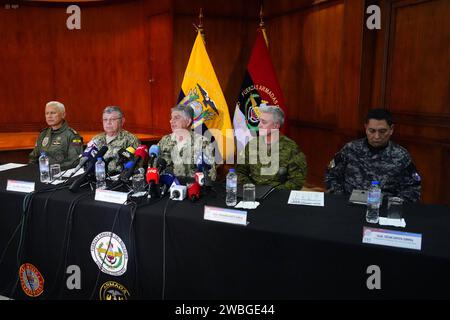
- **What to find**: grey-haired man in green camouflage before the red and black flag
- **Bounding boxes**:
[236,106,307,190]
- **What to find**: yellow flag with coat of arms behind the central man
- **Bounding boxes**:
[178,31,234,163]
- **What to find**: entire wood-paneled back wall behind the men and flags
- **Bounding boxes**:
[0,0,450,204]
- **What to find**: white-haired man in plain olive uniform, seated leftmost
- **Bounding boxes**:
[29,101,83,170]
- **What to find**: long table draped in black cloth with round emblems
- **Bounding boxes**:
[0,166,450,300]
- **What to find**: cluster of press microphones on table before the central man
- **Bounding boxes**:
[69,144,211,201]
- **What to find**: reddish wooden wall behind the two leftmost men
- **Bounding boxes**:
[0,0,173,132]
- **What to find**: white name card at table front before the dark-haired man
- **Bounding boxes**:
[363,227,422,250]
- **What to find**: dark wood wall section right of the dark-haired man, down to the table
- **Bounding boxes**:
[370,0,450,204]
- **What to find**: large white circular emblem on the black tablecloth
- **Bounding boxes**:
[91,231,128,276]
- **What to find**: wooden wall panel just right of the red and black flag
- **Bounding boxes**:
[267,2,344,126]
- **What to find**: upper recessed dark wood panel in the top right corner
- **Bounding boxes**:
[386,0,450,117]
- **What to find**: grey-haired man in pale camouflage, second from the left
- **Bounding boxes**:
[88,106,140,175]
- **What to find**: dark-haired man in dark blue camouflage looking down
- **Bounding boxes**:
[325,109,421,202]
